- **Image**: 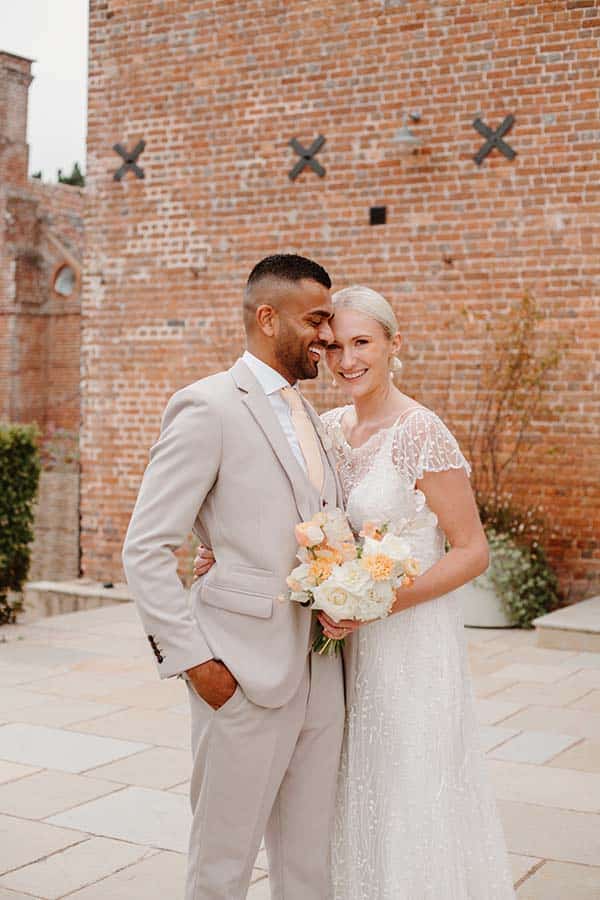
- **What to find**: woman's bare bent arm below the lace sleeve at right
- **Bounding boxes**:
[392,469,489,612]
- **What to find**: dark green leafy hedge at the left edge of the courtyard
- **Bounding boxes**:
[0,424,40,625]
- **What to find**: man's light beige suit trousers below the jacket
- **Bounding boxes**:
[186,654,344,900]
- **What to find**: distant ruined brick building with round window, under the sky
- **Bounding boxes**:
[0,52,83,431]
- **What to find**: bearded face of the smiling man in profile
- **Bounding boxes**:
[273,278,333,381]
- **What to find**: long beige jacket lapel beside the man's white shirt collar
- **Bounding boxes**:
[230,360,314,521]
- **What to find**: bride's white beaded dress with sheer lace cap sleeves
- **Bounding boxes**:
[323,407,515,900]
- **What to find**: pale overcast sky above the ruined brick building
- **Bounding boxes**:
[0,0,88,181]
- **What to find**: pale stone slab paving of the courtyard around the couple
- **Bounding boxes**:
[0,604,600,900]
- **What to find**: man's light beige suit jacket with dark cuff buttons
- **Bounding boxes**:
[123,360,342,707]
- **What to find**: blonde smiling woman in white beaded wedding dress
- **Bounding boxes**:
[196,286,515,900]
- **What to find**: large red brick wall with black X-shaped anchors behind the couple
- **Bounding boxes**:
[82,0,600,597]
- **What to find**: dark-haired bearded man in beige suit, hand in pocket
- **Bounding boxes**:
[123,254,344,900]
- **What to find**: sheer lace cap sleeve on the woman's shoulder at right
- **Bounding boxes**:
[392,408,471,485]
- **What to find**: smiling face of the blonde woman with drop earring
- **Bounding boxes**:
[327,309,400,399]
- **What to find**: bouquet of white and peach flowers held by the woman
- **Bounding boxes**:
[285,509,419,655]
